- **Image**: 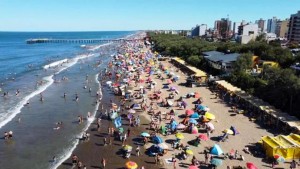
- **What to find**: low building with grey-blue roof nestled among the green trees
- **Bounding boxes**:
[202,51,240,72]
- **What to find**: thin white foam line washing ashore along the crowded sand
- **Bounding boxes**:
[51,74,102,169]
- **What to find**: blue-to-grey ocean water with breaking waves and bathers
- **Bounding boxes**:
[0,31,135,169]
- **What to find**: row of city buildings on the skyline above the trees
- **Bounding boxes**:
[156,11,300,44]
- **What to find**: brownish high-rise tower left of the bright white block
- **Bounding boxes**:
[215,18,232,39]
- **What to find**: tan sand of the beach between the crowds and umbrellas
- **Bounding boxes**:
[59,34,296,169]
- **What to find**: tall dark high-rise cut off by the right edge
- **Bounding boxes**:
[287,11,300,42]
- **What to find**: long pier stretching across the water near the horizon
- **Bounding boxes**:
[26,38,143,44]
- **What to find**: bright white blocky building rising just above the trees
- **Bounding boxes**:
[237,23,258,44]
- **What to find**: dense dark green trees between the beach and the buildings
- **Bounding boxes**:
[149,33,300,117]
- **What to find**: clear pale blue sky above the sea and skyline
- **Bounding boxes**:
[0,0,300,31]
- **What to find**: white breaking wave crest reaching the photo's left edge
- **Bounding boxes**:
[0,75,54,128]
